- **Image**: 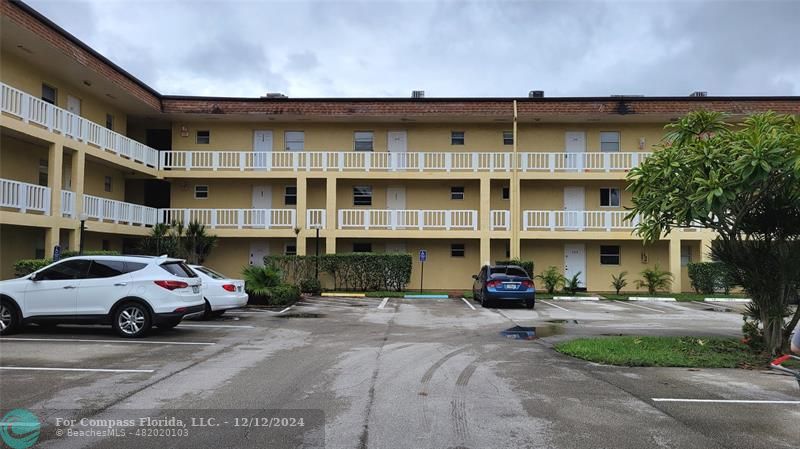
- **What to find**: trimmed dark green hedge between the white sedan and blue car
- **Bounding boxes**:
[264,253,412,291]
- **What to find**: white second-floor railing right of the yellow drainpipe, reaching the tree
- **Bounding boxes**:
[522,210,638,231]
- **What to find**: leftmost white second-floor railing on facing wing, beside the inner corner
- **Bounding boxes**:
[158,208,297,229]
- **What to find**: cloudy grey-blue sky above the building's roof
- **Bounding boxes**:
[27,0,800,97]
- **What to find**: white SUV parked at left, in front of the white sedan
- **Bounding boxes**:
[0,256,205,337]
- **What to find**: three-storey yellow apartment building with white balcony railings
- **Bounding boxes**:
[0,0,800,291]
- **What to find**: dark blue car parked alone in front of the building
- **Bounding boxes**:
[472,265,536,309]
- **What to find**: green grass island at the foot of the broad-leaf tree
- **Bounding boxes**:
[555,337,767,368]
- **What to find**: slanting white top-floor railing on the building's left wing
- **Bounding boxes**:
[0,83,158,167]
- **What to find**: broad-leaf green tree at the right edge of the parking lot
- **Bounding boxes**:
[628,111,800,353]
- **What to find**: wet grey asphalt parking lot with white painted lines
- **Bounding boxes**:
[0,298,800,448]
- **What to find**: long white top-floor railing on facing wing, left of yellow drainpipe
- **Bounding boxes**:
[160,151,512,172]
